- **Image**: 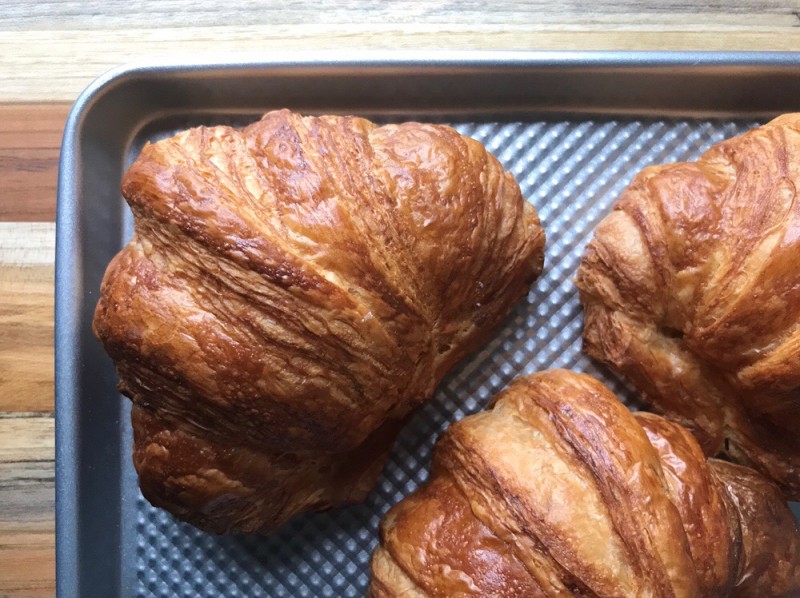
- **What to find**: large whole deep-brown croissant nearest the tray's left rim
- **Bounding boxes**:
[94,110,544,533]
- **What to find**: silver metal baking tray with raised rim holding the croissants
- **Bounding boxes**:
[55,52,800,598]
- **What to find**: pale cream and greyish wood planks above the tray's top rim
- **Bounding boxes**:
[0,0,800,101]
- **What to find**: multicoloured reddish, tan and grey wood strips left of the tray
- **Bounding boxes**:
[0,101,62,596]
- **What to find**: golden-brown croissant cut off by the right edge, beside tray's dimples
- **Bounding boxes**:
[576,114,800,499]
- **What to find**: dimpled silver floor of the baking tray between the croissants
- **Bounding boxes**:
[122,114,758,597]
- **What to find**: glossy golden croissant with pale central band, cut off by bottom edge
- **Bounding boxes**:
[369,370,800,598]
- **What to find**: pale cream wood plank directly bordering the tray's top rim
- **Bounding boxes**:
[0,27,800,102]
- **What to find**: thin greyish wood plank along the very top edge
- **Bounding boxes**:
[0,0,797,29]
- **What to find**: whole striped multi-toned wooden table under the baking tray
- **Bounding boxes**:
[0,0,800,596]
